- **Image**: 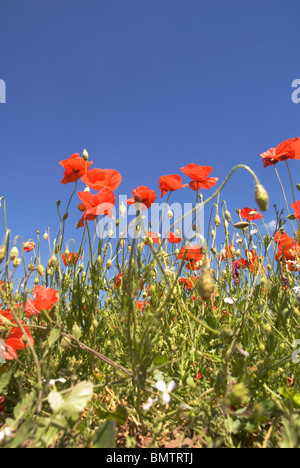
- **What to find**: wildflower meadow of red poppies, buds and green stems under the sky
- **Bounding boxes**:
[0,138,300,449]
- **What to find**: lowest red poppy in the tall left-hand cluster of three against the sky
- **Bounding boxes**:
[78,187,116,227]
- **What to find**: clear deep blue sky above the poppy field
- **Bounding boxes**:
[0,0,300,258]
